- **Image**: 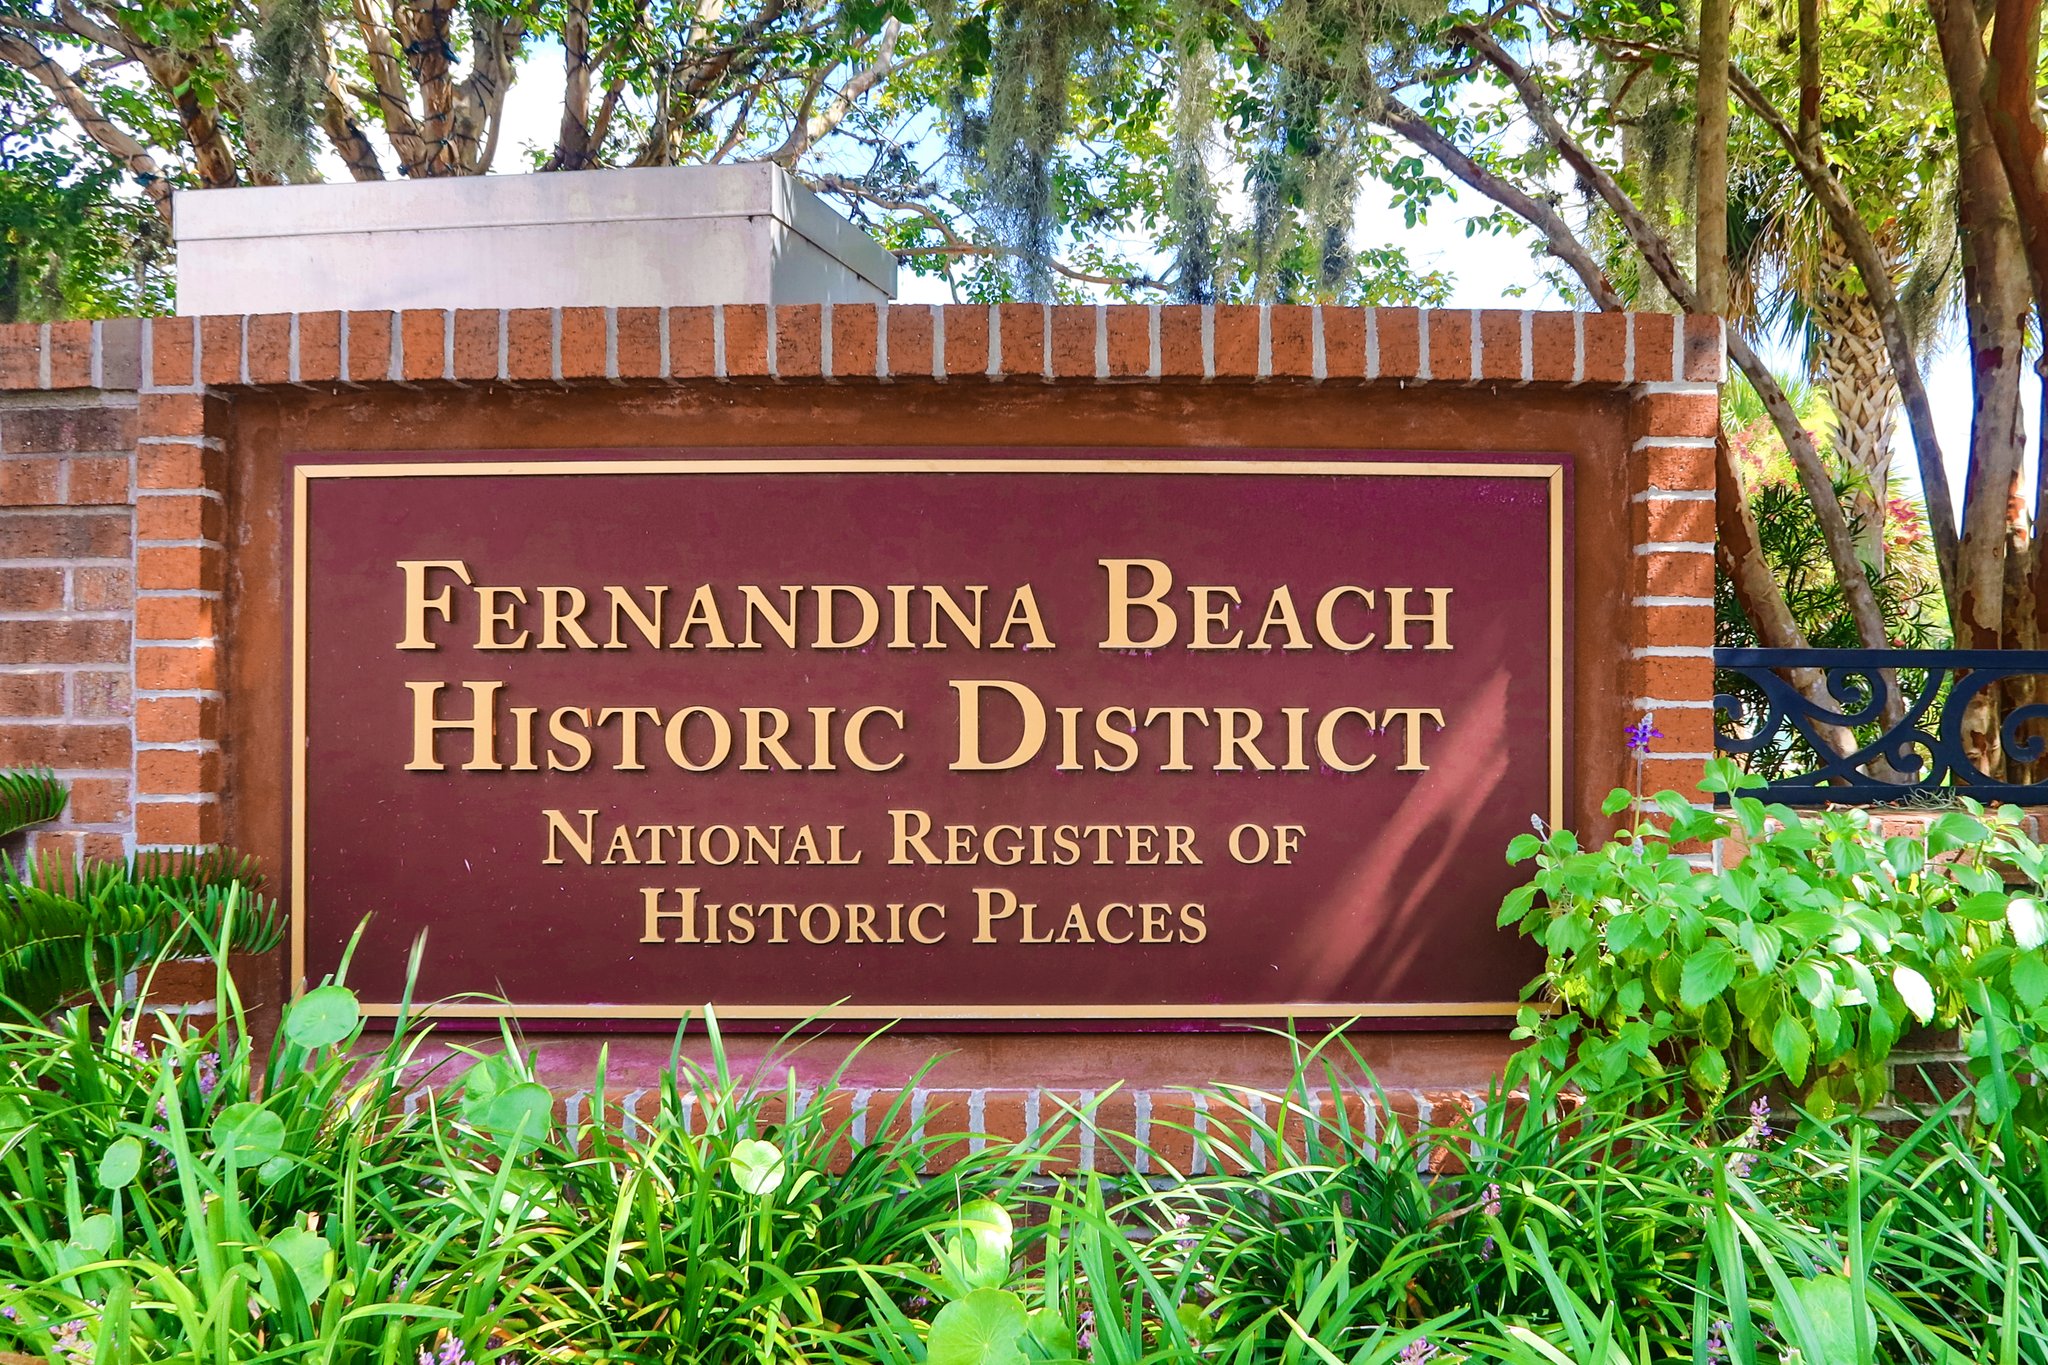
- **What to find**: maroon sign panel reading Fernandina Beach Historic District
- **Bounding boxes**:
[293,450,1569,1027]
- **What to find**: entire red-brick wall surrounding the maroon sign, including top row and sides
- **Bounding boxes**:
[0,305,1722,1166]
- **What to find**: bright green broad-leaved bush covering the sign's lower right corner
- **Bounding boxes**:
[1501,759,2048,1121]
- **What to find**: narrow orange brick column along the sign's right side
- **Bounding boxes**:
[1628,313,1724,796]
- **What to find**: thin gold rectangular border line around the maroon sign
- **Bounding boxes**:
[291,456,1565,1023]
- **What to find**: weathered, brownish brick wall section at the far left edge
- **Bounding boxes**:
[0,321,139,860]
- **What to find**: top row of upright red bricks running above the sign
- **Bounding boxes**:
[0,303,1726,391]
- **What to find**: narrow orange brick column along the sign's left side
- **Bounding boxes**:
[135,317,229,847]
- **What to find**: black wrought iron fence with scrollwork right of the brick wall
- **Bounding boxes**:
[1714,649,2048,806]
